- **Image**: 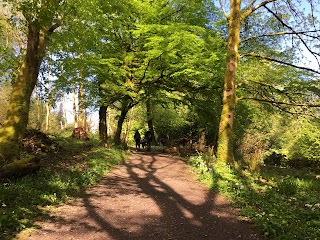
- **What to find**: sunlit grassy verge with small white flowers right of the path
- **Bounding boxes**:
[190,156,320,240]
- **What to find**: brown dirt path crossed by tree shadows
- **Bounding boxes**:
[18,153,263,240]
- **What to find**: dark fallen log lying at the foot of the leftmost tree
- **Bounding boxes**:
[0,156,40,178]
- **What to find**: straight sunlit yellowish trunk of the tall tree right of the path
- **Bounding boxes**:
[217,0,241,163]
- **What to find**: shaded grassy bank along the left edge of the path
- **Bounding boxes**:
[0,138,126,239]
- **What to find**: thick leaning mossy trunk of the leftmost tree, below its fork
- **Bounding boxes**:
[0,23,49,166]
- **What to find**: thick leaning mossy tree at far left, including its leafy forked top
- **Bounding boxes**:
[0,0,61,166]
